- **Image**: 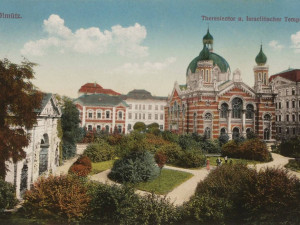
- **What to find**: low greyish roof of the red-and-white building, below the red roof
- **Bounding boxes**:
[74,94,128,107]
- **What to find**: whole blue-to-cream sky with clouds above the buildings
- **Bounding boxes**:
[0,0,300,97]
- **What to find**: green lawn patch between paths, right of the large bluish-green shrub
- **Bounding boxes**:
[135,169,193,194]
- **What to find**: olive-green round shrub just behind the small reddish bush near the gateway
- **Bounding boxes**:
[84,140,115,162]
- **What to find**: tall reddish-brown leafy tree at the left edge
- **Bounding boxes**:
[0,59,42,178]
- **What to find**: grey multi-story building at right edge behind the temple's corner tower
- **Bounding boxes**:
[270,69,300,139]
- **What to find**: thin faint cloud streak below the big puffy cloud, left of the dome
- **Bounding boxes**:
[113,57,176,74]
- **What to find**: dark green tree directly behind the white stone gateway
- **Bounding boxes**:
[61,97,82,159]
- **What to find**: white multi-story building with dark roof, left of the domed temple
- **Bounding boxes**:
[122,89,167,132]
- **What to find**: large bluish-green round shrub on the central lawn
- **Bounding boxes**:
[109,151,159,183]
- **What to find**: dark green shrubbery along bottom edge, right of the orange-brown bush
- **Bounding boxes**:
[90,184,180,225]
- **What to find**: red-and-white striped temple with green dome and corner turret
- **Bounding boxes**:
[165,30,276,140]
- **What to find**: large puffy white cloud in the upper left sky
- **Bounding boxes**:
[21,14,148,57]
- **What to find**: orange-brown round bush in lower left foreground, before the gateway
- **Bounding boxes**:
[23,175,91,221]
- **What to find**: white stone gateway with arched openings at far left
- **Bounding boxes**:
[5,94,61,198]
